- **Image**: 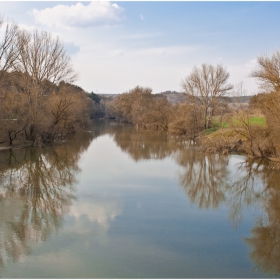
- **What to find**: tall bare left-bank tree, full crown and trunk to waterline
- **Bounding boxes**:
[14,30,77,141]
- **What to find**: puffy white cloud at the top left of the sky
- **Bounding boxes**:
[29,2,124,29]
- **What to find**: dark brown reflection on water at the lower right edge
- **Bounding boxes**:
[242,161,280,274]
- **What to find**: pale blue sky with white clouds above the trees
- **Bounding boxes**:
[0,1,280,94]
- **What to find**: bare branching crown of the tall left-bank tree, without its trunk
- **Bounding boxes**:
[16,30,77,89]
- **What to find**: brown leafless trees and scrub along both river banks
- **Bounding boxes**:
[0,13,280,163]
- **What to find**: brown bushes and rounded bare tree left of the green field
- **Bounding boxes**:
[107,64,233,138]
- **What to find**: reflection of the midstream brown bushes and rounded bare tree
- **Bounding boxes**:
[97,124,229,208]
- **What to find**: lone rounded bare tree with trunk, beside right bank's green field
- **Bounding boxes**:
[181,64,233,129]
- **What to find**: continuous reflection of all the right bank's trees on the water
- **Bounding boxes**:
[101,122,280,274]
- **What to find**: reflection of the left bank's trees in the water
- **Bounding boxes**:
[0,135,92,274]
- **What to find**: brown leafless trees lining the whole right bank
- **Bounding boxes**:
[100,48,280,158]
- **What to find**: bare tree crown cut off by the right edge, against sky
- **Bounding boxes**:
[251,50,280,93]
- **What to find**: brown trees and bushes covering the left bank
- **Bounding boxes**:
[0,14,90,145]
